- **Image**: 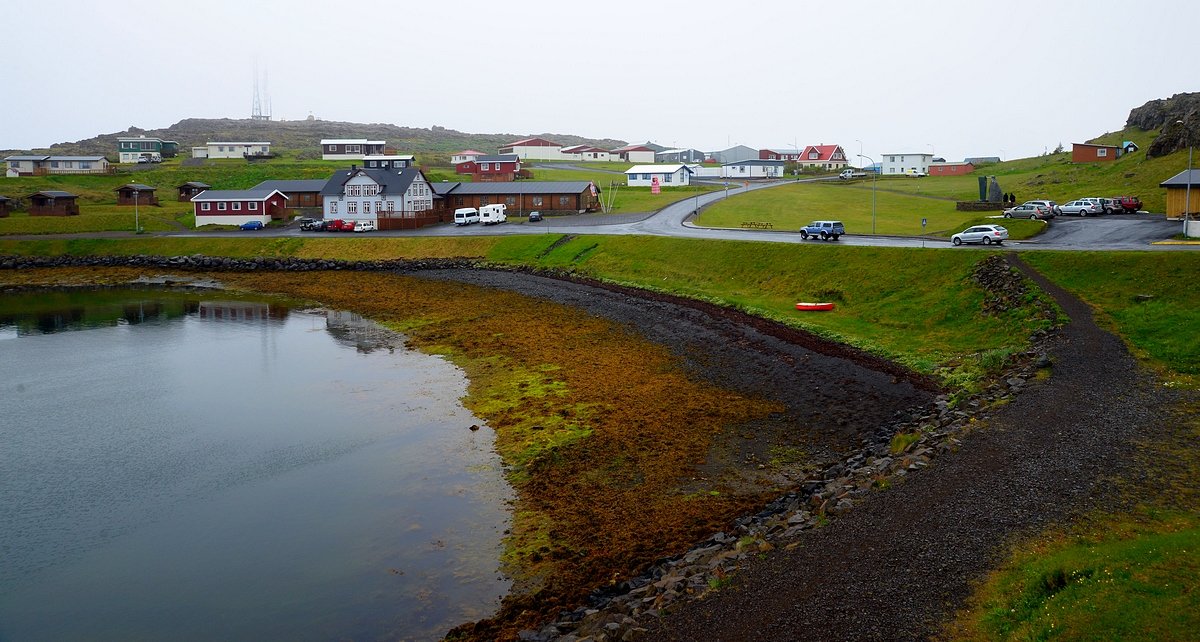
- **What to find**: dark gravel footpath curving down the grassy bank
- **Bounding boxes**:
[647,256,1169,641]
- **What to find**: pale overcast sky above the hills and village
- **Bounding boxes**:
[0,0,1200,160]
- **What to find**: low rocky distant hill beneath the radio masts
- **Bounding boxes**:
[0,118,626,163]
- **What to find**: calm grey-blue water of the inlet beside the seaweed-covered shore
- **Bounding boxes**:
[0,289,510,642]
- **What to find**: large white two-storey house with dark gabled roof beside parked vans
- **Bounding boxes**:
[320,167,433,222]
